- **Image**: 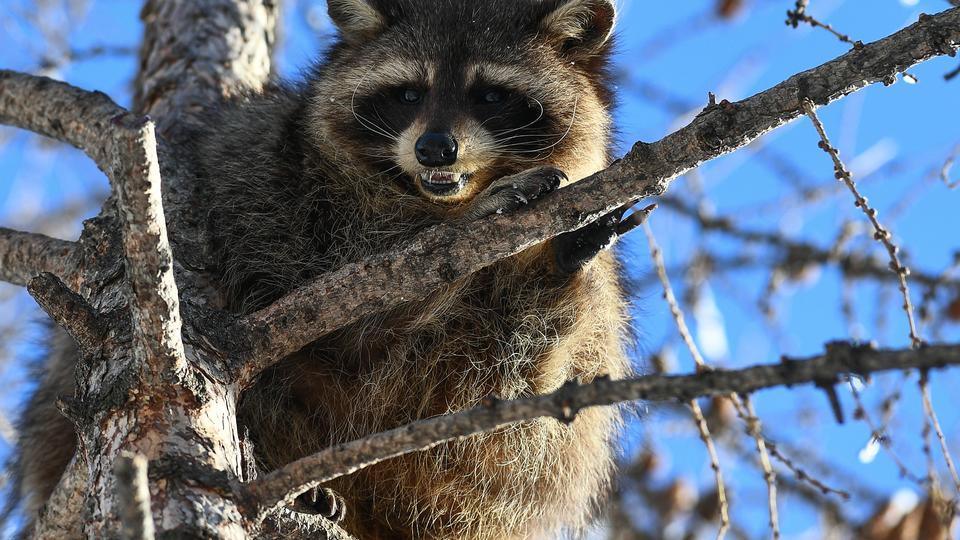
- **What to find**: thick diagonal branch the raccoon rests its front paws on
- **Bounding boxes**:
[235,8,960,384]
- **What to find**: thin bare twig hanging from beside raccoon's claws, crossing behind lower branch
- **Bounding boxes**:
[643,219,730,540]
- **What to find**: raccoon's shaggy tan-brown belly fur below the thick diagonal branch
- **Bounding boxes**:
[241,216,627,539]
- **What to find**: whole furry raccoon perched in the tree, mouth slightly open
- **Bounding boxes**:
[13,0,629,539]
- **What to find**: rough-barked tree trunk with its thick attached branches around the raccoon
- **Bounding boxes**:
[0,0,960,538]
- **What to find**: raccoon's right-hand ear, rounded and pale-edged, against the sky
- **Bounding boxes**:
[540,0,617,58]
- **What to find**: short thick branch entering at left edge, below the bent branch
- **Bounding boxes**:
[0,227,77,285]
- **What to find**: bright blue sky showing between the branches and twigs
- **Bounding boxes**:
[0,0,960,538]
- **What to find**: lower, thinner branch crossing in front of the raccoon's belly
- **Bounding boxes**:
[241,343,960,519]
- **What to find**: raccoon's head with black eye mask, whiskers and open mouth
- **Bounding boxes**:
[309,0,614,203]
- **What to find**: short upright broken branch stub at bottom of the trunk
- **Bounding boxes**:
[114,454,154,540]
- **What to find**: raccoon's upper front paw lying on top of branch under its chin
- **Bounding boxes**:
[463,167,567,221]
